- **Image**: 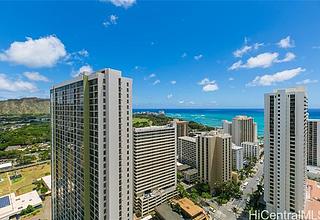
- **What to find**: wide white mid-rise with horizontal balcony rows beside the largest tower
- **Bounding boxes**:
[133,125,177,216]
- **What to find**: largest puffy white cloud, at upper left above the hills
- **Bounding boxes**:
[0,35,67,68]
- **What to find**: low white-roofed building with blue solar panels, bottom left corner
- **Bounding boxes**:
[0,191,42,220]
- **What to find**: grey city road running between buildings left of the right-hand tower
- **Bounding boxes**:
[208,162,263,220]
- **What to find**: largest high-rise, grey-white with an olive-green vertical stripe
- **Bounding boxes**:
[50,69,133,220]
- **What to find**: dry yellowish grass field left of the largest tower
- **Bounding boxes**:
[0,164,50,196]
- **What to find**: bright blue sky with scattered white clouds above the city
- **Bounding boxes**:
[0,0,320,108]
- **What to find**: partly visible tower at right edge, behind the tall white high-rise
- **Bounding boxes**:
[307,119,320,167]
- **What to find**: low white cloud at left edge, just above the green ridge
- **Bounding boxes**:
[0,73,38,92]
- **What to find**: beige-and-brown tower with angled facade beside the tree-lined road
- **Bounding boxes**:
[197,131,232,188]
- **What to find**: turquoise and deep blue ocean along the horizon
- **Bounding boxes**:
[133,109,320,136]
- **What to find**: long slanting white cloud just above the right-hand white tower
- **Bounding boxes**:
[247,67,305,86]
